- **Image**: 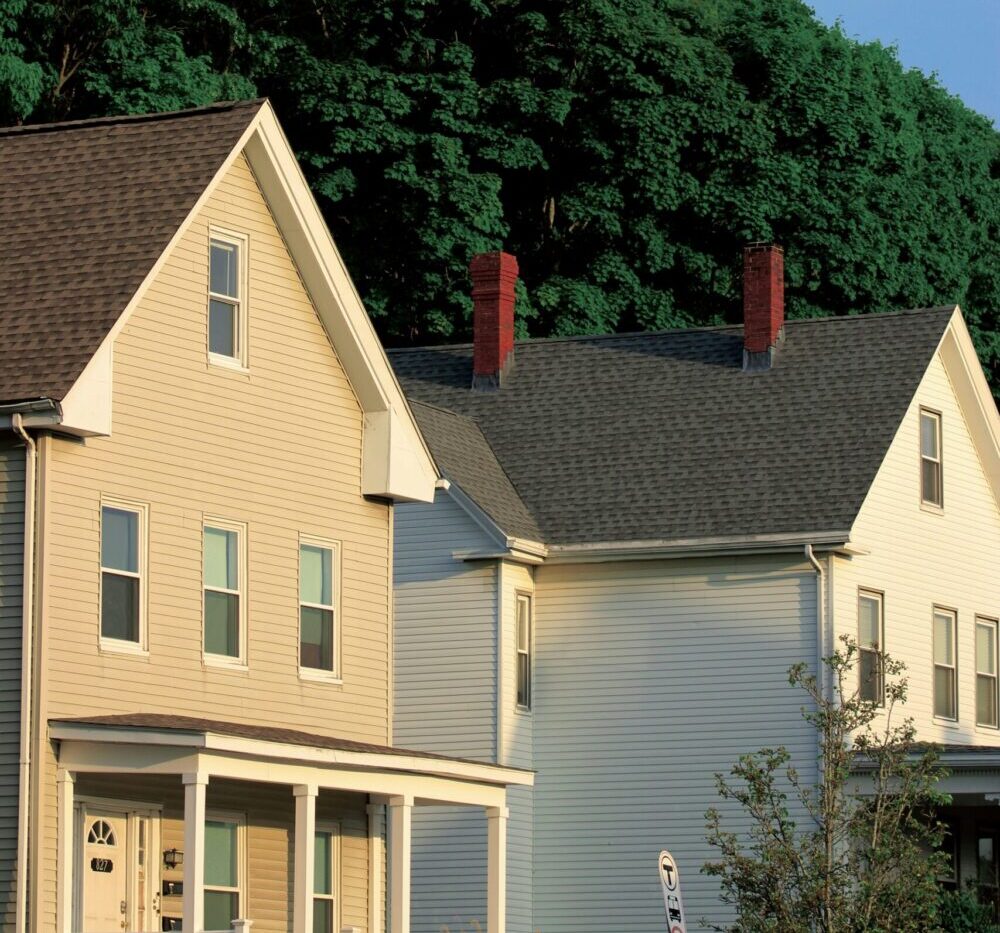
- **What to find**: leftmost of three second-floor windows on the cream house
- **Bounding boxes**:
[101,500,147,650]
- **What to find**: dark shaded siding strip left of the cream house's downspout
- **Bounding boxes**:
[0,440,24,930]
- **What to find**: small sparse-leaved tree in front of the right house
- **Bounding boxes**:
[703,638,948,933]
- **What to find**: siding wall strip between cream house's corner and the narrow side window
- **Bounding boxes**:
[393,491,497,933]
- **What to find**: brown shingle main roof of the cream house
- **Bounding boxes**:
[0,101,261,401]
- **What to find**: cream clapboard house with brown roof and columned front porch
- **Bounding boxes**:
[0,101,531,933]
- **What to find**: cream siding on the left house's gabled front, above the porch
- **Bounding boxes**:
[35,157,391,924]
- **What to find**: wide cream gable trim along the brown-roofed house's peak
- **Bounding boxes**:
[3,100,438,502]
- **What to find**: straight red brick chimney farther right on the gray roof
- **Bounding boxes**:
[743,243,785,370]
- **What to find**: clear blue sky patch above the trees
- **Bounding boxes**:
[806,0,1000,127]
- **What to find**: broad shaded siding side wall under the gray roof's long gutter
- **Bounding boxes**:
[533,558,816,933]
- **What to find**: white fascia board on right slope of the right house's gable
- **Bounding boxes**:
[938,305,1000,507]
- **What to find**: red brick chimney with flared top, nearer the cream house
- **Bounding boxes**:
[469,252,517,389]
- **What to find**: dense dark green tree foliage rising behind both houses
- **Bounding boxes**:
[0,0,1000,386]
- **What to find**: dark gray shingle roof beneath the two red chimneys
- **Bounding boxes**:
[389,307,954,545]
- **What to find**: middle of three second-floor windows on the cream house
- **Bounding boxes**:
[204,522,245,663]
